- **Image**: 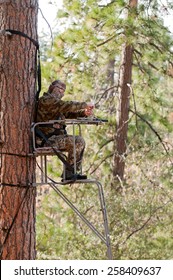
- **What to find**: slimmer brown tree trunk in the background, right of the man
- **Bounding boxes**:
[113,0,138,180]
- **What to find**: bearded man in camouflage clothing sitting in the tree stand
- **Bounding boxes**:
[37,80,94,180]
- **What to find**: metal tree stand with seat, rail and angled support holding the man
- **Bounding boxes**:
[31,118,112,260]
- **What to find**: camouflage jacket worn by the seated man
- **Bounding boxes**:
[37,93,87,135]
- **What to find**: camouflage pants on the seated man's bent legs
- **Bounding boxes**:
[45,135,85,170]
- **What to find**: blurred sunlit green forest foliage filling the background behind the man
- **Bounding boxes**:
[37,0,173,259]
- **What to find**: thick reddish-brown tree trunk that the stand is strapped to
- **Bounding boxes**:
[0,0,38,260]
